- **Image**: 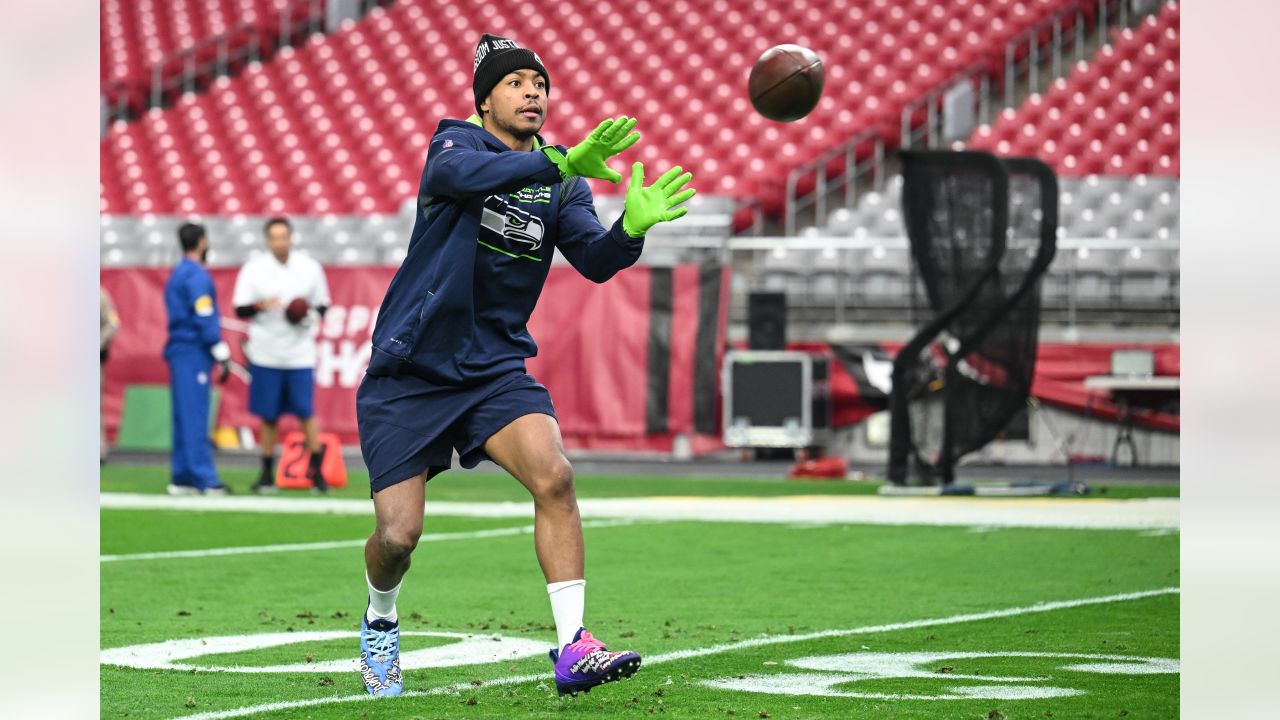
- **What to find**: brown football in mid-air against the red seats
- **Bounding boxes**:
[746,45,826,123]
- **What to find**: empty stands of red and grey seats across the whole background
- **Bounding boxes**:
[100,0,1179,327]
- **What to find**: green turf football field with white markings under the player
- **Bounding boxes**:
[101,466,1179,720]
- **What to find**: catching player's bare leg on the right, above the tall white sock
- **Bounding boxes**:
[484,414,584,583]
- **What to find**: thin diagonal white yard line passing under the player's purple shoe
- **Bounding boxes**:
[174,587,1181,720]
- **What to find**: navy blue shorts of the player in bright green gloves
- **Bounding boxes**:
[356,372,556,493]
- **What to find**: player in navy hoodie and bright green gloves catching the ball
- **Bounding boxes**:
[356,35,694,696]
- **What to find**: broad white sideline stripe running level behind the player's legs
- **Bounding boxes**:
[101,492,1179,530]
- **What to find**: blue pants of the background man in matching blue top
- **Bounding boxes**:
[165,347,219,489]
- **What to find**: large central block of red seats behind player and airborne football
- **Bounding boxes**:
[102,0,1111,215]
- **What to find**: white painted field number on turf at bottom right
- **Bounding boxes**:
[701,652,1179,700]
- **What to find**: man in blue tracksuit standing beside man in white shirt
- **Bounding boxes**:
[164,223,230,495]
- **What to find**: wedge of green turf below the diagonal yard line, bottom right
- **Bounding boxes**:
[117,592,1178,720]
